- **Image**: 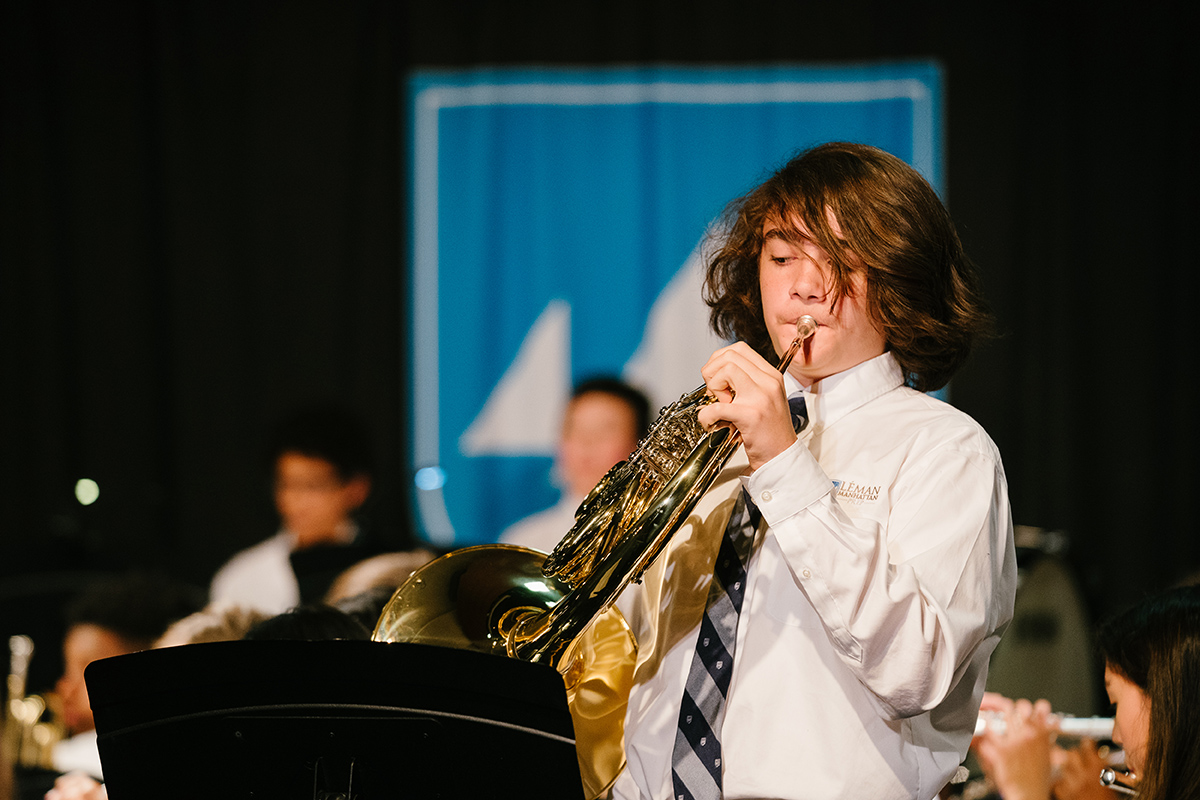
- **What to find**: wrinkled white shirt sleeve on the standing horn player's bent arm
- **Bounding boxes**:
[743,440,1012,718]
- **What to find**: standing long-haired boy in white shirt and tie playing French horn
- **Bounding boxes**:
[613,143,1016,800]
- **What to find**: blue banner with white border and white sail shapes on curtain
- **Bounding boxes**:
[408,62,944,547]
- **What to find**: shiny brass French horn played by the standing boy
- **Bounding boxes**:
[372,315,817,798]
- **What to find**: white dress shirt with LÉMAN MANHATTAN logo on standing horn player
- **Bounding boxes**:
[613,354,1016,800]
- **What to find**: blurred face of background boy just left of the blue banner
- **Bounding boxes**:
[275,452,370,549]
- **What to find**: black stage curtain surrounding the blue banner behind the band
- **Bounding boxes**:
[0,0,1200,633]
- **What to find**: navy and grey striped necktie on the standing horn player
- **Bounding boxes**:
[671,396,808,800]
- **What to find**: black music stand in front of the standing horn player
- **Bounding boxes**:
[85,642,583,800]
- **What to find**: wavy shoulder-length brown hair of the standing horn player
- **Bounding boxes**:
[704,142,991,391]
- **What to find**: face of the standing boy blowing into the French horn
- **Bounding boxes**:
[758,213,887,386]
